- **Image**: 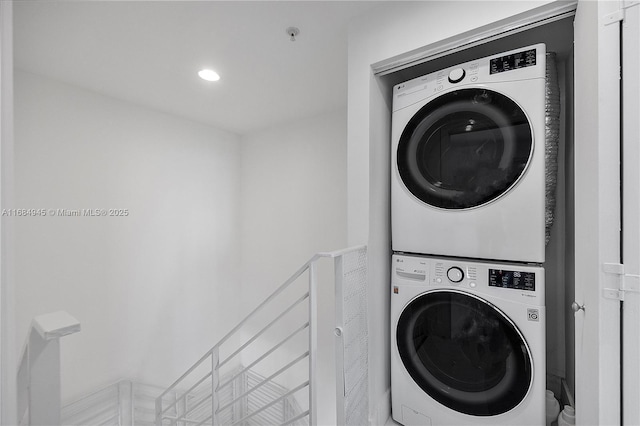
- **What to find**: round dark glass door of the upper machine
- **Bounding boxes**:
[397,89,533,209]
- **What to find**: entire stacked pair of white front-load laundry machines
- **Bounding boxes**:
[391,44,546,426]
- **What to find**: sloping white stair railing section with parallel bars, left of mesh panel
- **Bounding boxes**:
[156,247,366,426]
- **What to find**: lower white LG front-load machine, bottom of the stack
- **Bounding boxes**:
[391,255,546,426]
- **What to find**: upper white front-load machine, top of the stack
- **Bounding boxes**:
[391,44,546,263]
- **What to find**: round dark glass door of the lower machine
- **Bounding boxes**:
[396,291,533,416]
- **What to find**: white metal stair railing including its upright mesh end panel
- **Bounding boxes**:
[156,247,368,426]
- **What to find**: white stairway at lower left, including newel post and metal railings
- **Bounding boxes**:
[16,247,369,426]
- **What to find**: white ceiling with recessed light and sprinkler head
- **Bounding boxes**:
[14,0,379,134]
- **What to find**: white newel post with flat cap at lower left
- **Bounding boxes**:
[17,311,80,426]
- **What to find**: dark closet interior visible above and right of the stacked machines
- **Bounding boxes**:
[378,5,575,412]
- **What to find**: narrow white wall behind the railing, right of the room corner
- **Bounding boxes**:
[241,110,347,425]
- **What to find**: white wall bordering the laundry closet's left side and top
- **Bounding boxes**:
[347,1,549,424]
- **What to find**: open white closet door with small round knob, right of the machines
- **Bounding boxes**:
[574,1,621,425]
